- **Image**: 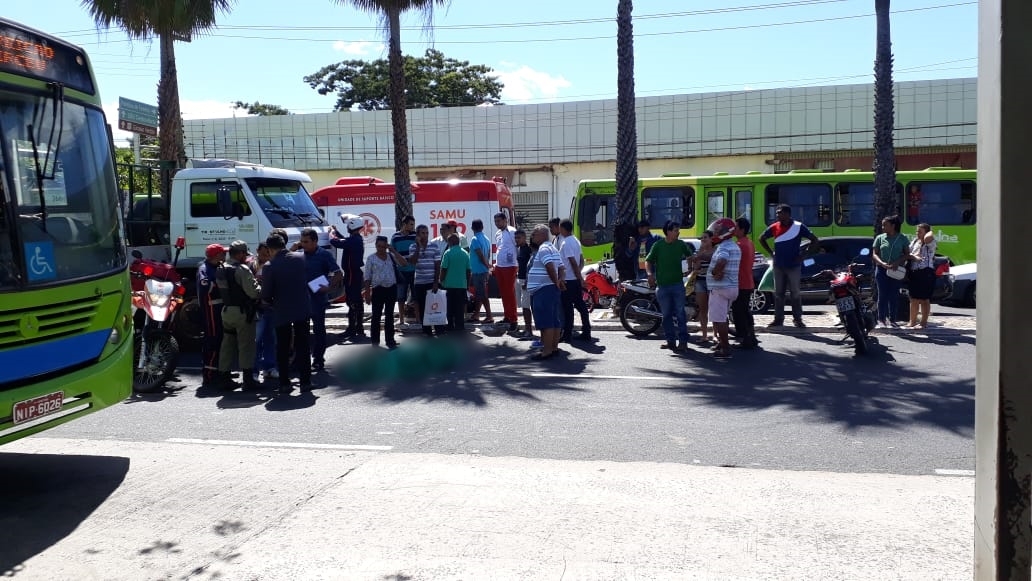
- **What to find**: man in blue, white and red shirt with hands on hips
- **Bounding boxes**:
[760,203,818,328]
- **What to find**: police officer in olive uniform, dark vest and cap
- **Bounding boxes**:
[217,240,261,389]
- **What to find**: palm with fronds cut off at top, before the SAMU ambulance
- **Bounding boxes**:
[335,0,450,227]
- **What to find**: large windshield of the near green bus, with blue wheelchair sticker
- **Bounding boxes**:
[0,91,126,291]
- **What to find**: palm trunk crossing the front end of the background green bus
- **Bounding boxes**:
[613,0,635,278]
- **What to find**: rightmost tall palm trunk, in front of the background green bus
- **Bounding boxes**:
[874,0,900,234]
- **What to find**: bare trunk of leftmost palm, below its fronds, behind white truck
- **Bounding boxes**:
[158,34,187,201]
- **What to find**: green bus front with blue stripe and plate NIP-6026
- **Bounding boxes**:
[0,19,133,444]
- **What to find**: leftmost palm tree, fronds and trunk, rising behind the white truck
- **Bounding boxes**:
[80,0,234,192]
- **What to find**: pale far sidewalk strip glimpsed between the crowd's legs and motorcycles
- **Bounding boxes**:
[326,298,975,335]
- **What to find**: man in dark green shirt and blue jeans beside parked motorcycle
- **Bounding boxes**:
[645,221,692,353]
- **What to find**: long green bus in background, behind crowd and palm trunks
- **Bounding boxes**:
[570,167,975,264]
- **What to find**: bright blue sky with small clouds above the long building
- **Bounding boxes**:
[3,0,977,144]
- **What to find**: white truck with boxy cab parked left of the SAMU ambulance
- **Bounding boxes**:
[126,159,333,340]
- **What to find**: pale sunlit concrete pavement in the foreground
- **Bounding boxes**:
[0,437,974,581]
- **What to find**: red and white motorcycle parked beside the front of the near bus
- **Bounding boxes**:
[129,236,187,393]
